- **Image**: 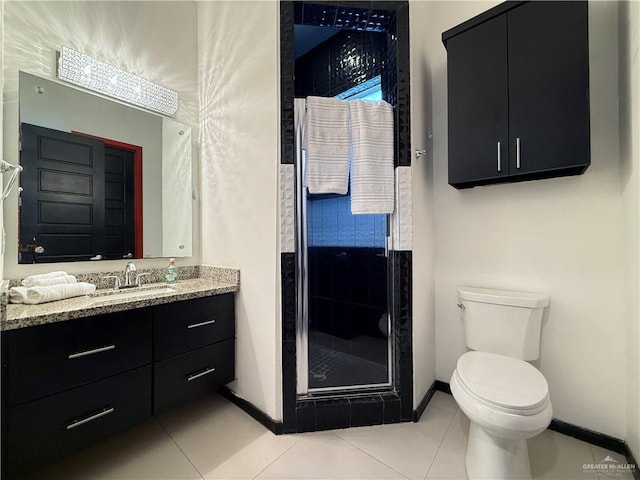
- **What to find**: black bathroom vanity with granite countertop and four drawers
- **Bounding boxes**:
[2,279,238,478]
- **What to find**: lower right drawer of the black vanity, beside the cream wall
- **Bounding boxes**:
[153,339,235,414]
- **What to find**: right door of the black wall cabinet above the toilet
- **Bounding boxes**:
[507,2,590,175]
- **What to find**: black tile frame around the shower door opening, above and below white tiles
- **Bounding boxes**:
[280,0,413,433]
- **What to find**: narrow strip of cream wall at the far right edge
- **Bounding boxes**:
[618,1,640,459]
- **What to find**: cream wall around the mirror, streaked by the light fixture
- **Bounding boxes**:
[2,1,200,278]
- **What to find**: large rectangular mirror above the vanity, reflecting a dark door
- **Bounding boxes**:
[18,72,192,263]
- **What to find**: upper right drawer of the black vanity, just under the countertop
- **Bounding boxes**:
[154,293,235,360]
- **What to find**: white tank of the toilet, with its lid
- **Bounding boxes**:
[458,287,549,361]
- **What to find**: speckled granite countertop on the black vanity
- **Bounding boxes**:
[1,276,239,331]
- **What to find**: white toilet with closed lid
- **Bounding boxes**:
[450,287,553,480]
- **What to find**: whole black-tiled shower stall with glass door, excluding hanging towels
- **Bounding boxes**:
[280,0,414,433]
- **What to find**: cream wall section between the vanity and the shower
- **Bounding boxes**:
[198,1,282,420]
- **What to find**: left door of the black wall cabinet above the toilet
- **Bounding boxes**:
[447,15,509,187]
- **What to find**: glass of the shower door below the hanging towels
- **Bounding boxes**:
[306,194,390,392]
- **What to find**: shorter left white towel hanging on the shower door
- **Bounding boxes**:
[305,97,351,195]
